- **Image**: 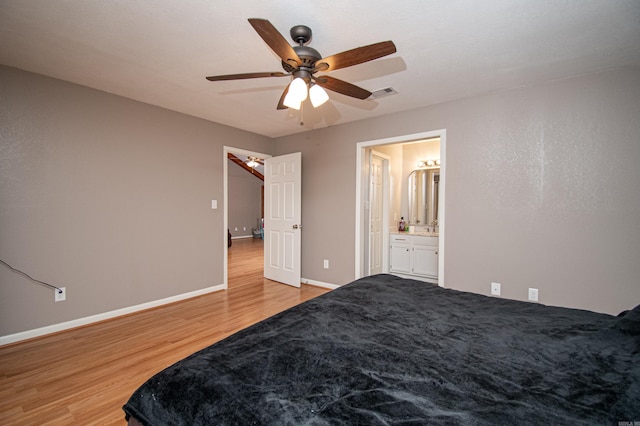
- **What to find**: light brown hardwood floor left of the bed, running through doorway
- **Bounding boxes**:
[0,239,328,425]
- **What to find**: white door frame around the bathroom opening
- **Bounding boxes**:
[355,129,447,287]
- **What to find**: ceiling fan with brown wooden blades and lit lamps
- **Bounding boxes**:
[207,18,396,109]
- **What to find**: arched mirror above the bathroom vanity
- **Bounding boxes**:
[407,168,440,226]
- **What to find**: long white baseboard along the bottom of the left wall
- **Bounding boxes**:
[0,284,227,346]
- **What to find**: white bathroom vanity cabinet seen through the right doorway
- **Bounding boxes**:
[389,233,438,282]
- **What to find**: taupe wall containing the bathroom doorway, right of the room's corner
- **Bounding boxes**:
[274,65,640,313]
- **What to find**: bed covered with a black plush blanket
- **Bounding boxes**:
[123,274,640,426]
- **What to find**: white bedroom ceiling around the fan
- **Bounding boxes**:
[0,0,640,137]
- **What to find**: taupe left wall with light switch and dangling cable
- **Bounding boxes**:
[0,67,272,336]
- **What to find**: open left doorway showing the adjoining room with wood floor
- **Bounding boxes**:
[223,146,270,288]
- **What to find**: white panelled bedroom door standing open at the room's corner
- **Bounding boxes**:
[264,152,302,287]
